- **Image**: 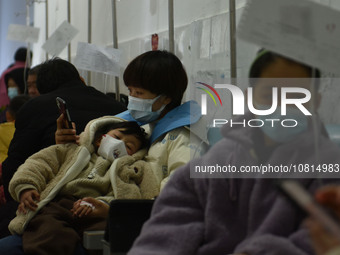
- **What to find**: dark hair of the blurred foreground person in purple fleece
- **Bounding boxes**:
[249,49,321,88]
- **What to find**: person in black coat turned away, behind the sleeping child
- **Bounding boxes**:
[0,58,126,237]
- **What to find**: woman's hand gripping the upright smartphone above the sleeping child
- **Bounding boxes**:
[55,114,79,144]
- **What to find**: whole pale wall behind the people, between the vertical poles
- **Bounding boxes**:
[30,0,340,98]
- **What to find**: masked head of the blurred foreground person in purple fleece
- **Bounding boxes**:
[249,49,325,152]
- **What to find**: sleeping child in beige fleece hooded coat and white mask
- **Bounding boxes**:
[0,117,150,255]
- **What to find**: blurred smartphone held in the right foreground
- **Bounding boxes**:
[277,180,340,240]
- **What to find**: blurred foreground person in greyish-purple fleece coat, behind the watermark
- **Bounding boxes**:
[128,51,340,255]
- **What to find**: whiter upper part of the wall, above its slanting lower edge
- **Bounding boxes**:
[35,0,234,59]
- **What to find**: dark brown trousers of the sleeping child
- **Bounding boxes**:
[23,197,106,255]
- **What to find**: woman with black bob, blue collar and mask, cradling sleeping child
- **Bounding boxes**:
[56,51,205,191]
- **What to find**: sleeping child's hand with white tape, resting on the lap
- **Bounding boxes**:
[71,197,110,218]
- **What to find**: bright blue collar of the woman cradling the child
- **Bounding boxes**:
[116,101,201,144]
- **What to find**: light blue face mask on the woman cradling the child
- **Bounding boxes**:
[128,95,166,123]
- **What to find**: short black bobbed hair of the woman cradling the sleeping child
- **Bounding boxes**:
[123,50,188,110]
